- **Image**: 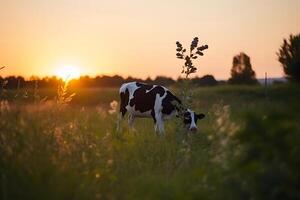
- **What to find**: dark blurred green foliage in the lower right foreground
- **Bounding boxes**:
[233,110,300,200]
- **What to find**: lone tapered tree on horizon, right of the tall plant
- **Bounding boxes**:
[228,52,258,84]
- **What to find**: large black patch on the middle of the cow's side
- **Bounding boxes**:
[129,83,165,113]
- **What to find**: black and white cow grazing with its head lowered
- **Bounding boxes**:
[119,82,205,133]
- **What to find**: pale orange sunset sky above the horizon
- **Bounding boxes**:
[0,0,300,79]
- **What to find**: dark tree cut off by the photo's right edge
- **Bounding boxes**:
[277,34,300,81]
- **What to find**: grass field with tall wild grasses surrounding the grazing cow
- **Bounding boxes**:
[0,84,300,200]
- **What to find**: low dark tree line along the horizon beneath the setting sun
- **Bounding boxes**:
[0,75,219,89]
